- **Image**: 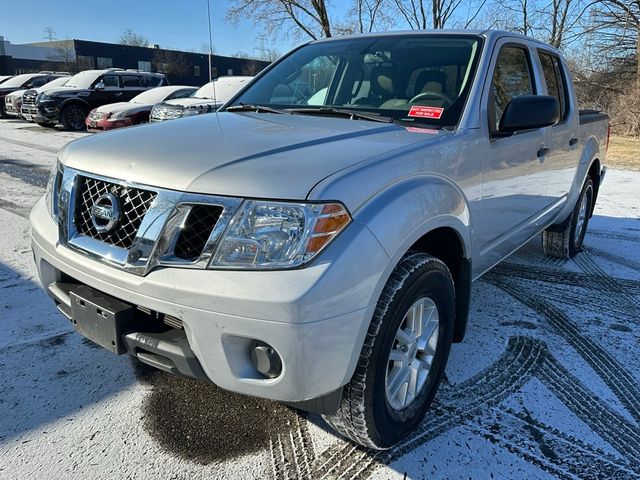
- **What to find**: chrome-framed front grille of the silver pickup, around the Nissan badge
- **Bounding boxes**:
[54,167,242,275]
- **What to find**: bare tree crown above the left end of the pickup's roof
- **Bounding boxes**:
[227,0,332,40]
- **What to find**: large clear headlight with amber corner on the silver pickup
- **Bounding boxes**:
[209,200,351,270]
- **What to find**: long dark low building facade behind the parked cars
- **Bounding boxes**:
[0,40,269,86]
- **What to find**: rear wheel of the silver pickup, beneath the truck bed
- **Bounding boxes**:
[542,176,594,259]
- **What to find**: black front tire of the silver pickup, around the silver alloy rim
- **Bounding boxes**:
[324,252,455,449]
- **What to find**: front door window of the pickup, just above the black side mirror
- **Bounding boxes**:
[489,45,536,132]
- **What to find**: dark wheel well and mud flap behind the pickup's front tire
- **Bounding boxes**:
[410,227,471,342]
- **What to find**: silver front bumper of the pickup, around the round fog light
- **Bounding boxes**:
[30,200,389,402]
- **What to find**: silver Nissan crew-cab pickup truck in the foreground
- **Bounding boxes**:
[31,31,608,449]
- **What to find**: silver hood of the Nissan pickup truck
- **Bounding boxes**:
[59,112,449,200]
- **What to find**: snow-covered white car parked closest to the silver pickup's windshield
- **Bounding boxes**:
[150,76,253,122]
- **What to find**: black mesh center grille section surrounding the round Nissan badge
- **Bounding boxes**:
[75,176,156,249]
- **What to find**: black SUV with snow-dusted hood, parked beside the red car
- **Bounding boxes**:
[34,68,167,130]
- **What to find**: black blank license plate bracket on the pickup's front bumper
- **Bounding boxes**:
[69,285,136,355]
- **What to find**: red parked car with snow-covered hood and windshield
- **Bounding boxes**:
[85,85,198,131]
